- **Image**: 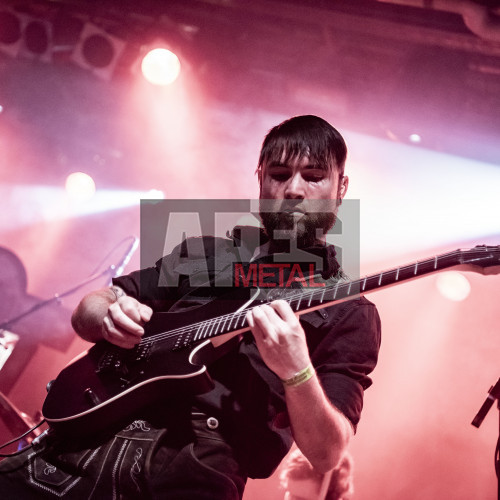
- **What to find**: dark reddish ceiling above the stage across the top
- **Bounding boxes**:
[2,0,500,164]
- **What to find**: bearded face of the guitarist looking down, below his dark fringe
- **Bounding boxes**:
[260,154,347,248]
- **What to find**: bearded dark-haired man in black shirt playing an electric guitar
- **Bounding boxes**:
[0,116,380,500]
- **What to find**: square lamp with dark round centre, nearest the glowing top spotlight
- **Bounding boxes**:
[71,23,126,80]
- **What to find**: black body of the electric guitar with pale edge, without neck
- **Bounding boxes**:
[42,304,244,435]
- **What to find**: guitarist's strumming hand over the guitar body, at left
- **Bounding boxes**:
[102,295,153,349]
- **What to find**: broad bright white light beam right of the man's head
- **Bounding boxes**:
[346,132,500,262]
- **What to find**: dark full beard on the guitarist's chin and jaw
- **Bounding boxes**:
[260,200,337,251]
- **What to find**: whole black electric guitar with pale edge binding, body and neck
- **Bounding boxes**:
[42,245,500,435]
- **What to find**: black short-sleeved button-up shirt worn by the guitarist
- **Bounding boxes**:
[113,228,380,477]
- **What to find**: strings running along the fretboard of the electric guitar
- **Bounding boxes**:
[131,247,498,345]
